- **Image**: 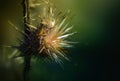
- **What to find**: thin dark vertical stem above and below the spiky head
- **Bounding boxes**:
[22,0,31,81]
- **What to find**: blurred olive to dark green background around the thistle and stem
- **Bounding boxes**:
[0,0,120,81]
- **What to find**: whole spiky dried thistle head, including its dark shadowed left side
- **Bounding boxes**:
[9,1,74,63]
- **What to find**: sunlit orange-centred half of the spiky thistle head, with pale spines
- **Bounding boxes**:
[35,3,74,62]
